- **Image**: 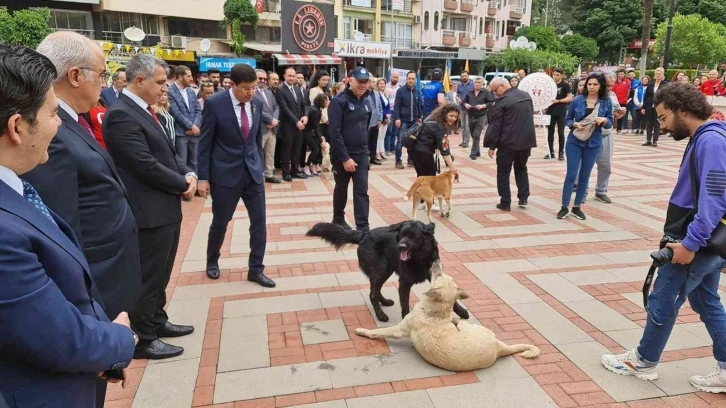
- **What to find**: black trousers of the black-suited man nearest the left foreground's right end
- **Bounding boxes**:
[129,222,181,342]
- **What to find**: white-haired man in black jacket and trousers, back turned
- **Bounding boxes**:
[484,77,537,211]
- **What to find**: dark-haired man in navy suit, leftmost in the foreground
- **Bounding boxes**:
[0,44,135,408]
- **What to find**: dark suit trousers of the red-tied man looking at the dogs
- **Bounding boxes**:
[207,166,267,274]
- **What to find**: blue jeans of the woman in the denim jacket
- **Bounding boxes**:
[562,141,602,207]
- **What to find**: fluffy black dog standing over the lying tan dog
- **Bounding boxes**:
[305,221,469,322]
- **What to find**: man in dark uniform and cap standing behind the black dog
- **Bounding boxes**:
[328,67,373,231]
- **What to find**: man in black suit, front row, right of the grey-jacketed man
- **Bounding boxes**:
[275,67,308,181]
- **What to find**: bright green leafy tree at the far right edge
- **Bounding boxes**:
[655,14,726,66]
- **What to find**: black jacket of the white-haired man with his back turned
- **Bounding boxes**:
[484,88,537,151]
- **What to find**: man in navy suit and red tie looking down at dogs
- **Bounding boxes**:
[199,64,275,288]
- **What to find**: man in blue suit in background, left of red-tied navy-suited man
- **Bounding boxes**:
[169,65,202,171]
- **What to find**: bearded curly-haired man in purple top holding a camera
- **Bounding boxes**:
[602,84,726,392]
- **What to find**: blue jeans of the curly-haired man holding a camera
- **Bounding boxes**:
[638,253,726,363]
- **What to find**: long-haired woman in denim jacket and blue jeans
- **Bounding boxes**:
[557,73,613,220]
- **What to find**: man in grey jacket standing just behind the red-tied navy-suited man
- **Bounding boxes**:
[255,69,281,184]
